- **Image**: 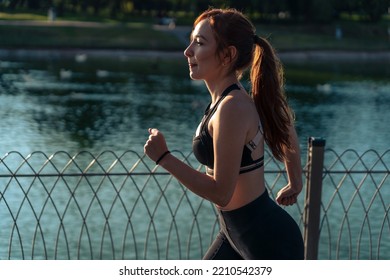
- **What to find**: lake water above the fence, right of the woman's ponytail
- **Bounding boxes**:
[286,62,390,152]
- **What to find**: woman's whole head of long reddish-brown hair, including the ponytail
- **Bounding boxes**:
[194,9,293,160]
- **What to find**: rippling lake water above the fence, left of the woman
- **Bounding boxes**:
[0,55,208,154]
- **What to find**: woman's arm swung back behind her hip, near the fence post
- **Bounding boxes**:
[276,126,303,206]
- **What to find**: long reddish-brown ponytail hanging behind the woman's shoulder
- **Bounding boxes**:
[250,35,293,161]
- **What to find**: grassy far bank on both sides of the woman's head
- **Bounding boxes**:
[0,13,390,51]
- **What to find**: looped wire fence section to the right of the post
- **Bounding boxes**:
[319,150,390,259]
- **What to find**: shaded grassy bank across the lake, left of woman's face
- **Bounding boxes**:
[0,24,180,50]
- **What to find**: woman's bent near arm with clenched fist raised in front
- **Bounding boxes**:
[144,98,246,207]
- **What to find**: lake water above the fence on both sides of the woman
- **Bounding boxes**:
[0,53,390,258]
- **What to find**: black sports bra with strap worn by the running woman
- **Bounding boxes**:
[192,84,264,174]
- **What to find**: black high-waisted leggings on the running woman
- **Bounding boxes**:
[203,191,304,260]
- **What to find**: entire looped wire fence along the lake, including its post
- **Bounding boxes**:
[0,138,390,259]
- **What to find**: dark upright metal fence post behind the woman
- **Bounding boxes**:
[303,137,325,260]
